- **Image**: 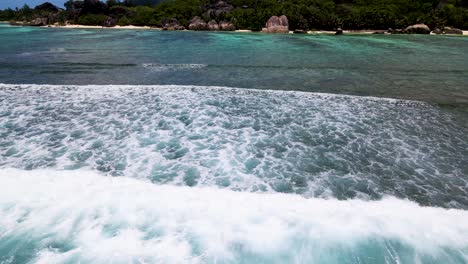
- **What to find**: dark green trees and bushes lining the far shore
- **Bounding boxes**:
[0,0,468,30]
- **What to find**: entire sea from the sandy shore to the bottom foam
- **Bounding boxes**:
[0,24,468,264]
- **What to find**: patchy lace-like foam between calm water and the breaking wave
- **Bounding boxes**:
[0,85,468,208]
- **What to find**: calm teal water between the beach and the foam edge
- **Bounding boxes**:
[0,24,468,104]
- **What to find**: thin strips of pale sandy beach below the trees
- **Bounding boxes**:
[0,21,468,36]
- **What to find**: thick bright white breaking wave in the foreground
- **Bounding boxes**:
[0,169,468,263]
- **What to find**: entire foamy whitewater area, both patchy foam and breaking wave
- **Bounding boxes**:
[0,84,468,264]
